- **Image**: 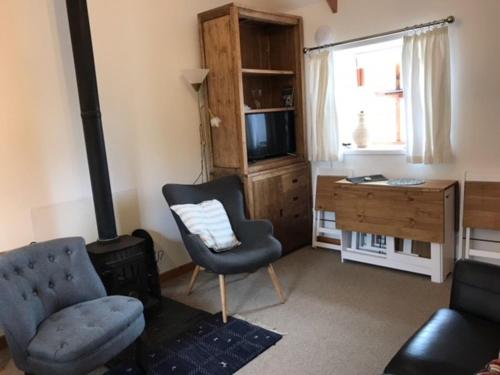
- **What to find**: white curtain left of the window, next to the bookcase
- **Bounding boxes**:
[306,51,341,161]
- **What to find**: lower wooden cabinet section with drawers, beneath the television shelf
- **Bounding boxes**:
[247,164,312,253]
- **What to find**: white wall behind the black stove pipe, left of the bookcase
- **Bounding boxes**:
[0,0,282,270]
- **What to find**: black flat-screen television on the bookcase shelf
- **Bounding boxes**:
[245,110,296,162]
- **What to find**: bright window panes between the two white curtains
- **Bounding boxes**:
[335,39,406,150]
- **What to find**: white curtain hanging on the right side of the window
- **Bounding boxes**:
[402,27,451,164]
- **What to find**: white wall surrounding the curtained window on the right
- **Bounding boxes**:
[292,0,500,179]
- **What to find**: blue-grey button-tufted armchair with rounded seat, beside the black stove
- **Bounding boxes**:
[0,238,144,375]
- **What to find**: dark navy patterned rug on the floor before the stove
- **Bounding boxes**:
[105,304,282,375]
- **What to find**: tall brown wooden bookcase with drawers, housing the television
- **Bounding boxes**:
[198,3,312,252]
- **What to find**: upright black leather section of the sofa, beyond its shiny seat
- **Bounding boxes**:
[450,260,500,323]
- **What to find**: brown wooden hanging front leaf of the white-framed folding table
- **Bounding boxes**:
[329,184,444,243]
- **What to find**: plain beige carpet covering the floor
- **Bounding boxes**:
[0,248,451,375]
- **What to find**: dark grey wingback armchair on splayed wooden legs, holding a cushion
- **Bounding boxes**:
[163,176,285,322]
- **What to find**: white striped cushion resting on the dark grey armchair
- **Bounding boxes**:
[170,199,241,251]
